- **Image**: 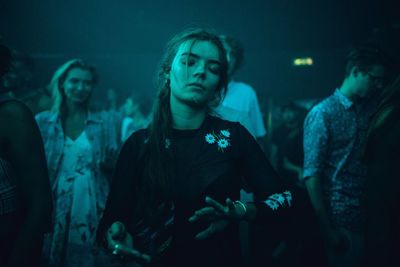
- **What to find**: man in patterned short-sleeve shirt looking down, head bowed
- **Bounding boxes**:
[303,45,386,267]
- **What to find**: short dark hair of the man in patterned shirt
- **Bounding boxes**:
[345,43,390,77]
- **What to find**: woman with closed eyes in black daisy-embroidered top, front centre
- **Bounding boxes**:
[97,29,296,267]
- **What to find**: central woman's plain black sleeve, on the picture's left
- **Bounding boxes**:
[96,130,145,246]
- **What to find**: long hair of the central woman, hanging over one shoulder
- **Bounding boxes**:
[139,29,228,214]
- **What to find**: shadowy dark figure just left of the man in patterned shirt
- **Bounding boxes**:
[268,102,326,267]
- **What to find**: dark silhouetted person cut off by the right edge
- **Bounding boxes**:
[365,74,400,267]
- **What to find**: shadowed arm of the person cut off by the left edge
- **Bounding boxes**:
[0,100,52,266]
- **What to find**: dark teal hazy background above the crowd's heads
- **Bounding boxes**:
[0,0,400,105]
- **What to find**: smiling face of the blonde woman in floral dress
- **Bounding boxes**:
[62,68,93,103]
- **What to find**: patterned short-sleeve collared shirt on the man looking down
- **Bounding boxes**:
[303,90,376,231]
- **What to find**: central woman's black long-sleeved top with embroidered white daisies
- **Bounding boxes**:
[98,116,291,266]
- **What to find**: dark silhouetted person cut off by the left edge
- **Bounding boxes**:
[0,45,52,267]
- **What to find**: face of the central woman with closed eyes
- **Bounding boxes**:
[169,40,222,108]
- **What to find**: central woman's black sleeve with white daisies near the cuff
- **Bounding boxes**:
[237,124,293,223]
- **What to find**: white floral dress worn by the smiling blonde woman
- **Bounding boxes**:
[46,131,102,267]
